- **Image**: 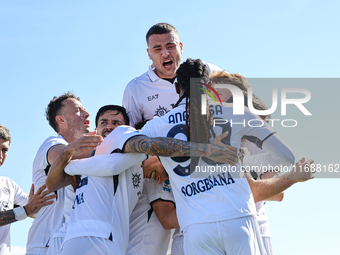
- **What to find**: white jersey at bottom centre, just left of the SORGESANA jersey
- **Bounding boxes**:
[126,179,175,255]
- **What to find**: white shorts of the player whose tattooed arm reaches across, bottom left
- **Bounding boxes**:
[60,236,118,255]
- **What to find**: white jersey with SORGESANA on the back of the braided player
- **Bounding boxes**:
[131,100,294,231]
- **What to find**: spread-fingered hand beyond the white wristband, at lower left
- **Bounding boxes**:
[25,184,56,217]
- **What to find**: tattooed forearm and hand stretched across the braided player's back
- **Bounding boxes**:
[124,132,238,165]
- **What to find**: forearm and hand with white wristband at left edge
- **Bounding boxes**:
[0,184,56,227]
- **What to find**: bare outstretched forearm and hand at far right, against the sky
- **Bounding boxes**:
[247,159,315,202]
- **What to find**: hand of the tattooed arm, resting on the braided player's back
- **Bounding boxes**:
[207,131,239,166]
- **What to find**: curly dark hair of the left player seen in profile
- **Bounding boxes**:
[46,92,80,133]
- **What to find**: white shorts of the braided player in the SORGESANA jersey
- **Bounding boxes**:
[183,216,266,255]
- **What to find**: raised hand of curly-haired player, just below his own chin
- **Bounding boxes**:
[65,131,103,156]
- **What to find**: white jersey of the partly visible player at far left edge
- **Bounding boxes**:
[0,176,28,255]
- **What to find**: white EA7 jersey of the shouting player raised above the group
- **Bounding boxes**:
[123,61,221,126]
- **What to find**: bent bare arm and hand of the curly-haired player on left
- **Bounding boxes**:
[46,131,103,190]
